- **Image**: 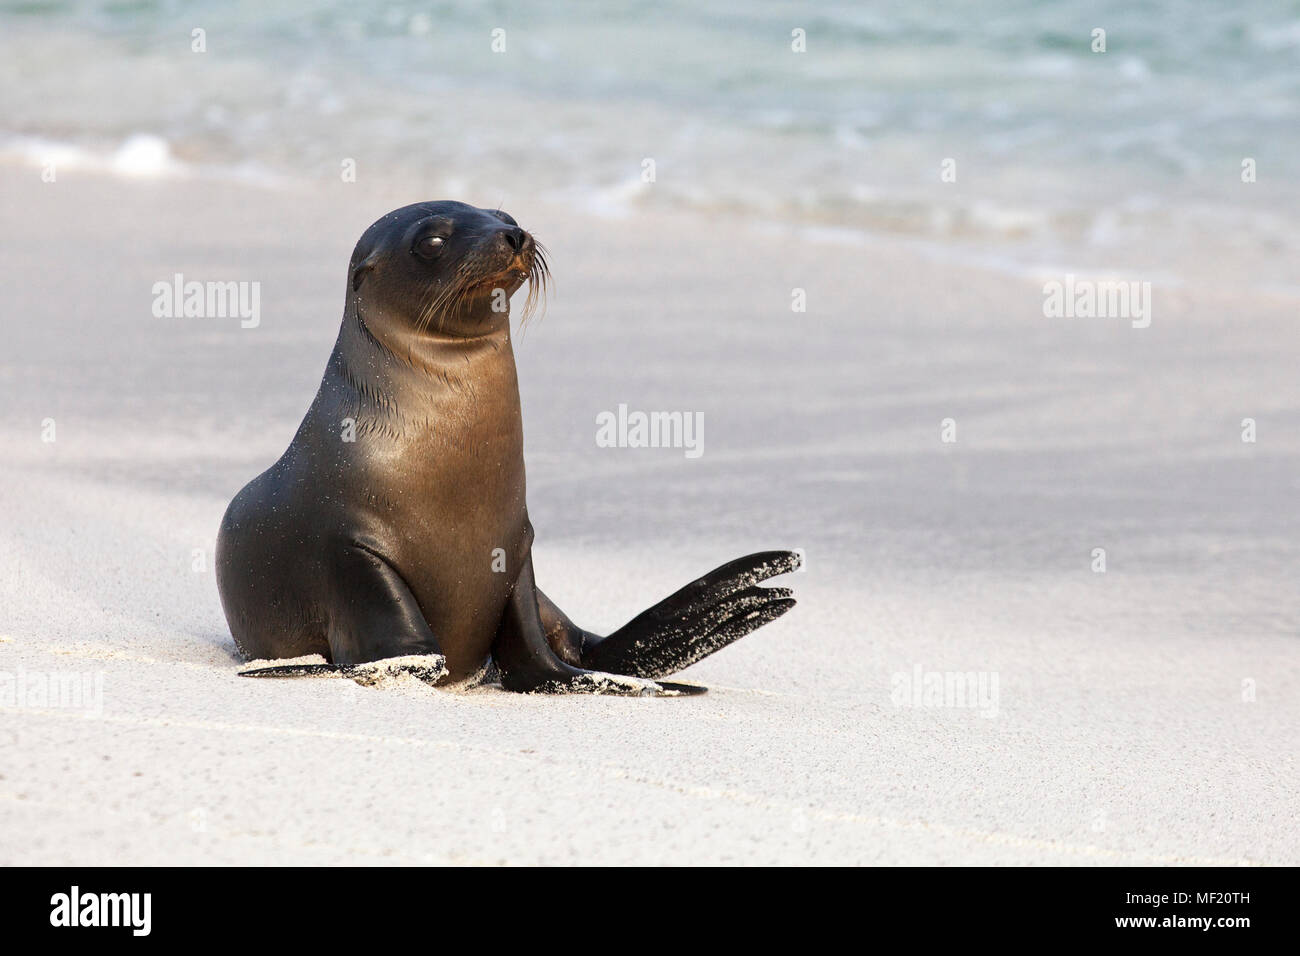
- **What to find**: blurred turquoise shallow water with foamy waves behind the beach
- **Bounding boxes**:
[0,0,1300,284]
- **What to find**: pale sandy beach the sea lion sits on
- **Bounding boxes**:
[0,168,1300,865]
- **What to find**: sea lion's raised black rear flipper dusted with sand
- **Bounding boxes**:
[581,551,802,679]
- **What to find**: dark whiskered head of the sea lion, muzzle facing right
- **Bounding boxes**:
[348,200,550,336]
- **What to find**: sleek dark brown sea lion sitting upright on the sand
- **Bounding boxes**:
[217,202,798,695]
